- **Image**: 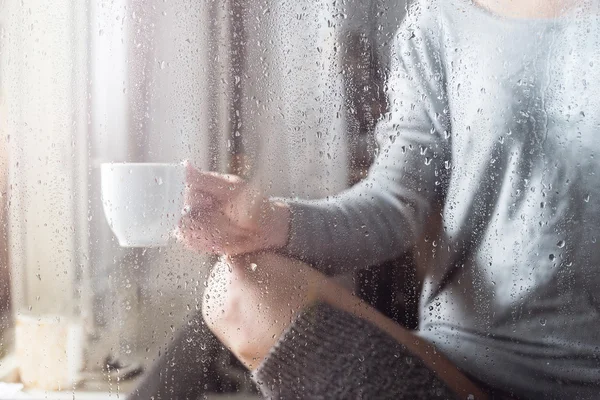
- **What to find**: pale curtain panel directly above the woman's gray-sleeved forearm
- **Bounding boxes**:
[239,0,406,198]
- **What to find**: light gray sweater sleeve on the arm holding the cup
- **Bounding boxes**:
[285,5,450,273]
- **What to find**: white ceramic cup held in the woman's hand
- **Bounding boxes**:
[101,163,185,247]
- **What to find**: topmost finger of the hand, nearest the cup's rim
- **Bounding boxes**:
[186,163,244,201]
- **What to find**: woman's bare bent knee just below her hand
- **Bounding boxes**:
[203,253,326,367]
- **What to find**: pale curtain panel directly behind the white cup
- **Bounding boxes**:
[90,0,227,359]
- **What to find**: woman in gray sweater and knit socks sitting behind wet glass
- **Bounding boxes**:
[136,0,600,399]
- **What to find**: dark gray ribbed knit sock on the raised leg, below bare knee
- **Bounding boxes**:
[253,304,456,399]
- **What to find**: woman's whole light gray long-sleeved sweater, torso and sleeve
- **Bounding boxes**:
[280,0,600,398]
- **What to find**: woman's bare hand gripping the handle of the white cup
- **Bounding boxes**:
[178,164,290,255]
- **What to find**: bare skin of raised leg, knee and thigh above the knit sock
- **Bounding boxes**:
[203,253,487,399]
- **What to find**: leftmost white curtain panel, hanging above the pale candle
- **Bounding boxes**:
[1,0,88,315]
